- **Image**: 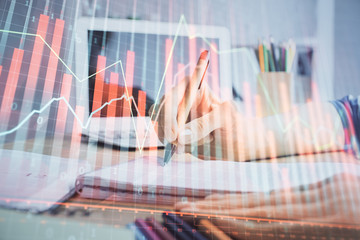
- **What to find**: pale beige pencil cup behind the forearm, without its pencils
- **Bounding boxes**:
[256,72,293,117]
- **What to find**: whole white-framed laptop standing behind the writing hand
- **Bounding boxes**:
[75,18,231,149]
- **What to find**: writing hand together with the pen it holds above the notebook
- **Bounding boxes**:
[150,49,261,164]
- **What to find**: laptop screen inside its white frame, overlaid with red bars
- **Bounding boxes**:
[88,30,220,117]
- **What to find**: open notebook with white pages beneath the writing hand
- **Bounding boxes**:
[76,157,360,199]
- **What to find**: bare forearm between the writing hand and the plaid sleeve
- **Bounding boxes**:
[263,102,344,157]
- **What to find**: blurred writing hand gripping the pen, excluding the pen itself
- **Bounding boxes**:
[150,77,266,161]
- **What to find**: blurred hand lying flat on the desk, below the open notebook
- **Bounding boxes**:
[175,173,360,224]
